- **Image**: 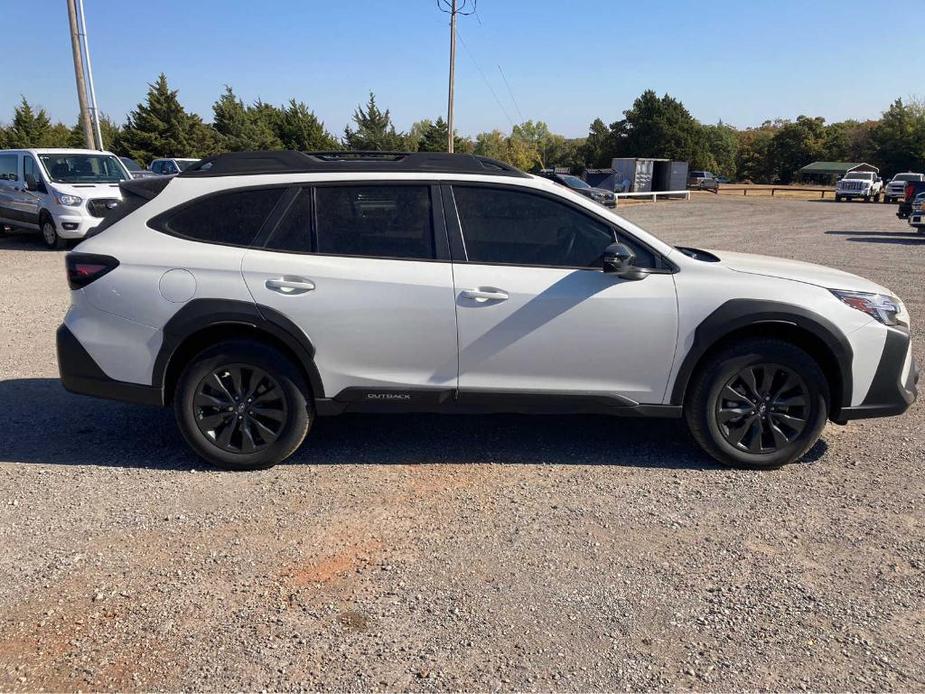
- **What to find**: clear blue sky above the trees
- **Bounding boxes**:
[0,0,925,136]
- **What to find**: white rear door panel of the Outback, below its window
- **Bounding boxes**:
[243,249,457,397]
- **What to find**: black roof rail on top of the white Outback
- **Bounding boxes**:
[178,150,527,178]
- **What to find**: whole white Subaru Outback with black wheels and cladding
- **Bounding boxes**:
[58,152,918,469]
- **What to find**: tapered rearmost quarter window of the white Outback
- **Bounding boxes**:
[151,188,285,246]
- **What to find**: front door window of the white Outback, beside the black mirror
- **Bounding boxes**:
[453,186,616,268]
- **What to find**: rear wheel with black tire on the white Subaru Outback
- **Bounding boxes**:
[174,340,315,470]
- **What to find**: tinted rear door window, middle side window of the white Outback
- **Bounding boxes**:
[315,185,435,260]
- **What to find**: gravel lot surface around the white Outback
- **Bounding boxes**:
[0,194,925,691]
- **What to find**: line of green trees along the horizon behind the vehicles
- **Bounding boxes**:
[0,74,925,183]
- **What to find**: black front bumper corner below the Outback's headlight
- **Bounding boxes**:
[833,329,919,424]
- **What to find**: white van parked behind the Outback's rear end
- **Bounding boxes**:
[0,149,132,249]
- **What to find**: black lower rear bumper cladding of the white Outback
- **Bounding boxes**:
[57,325,164,406]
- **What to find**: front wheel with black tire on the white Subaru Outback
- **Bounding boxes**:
[684,338,829,468]
